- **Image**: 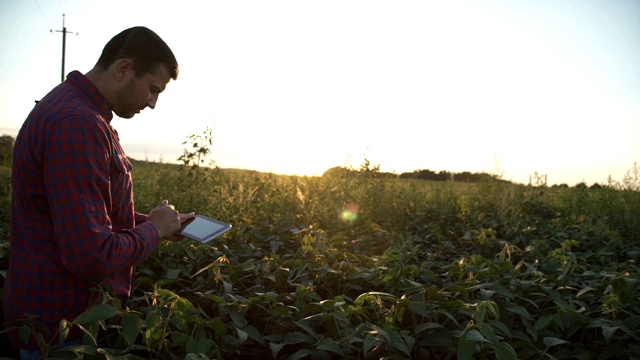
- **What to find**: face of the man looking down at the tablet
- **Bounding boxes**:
[113,65,171,119]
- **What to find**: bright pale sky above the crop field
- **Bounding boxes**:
[0,0,640,185]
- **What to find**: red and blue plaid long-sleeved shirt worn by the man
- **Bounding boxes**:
[3,71,159,349]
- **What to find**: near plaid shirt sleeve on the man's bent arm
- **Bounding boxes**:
[43,116,159,281]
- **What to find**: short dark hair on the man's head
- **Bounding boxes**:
[96,26,178,80]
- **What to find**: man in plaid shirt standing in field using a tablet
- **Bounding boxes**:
[3,27,194,358]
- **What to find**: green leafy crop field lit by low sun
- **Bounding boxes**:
[0,162,640,360]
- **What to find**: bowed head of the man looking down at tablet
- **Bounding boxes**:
[86,27,178,118]
